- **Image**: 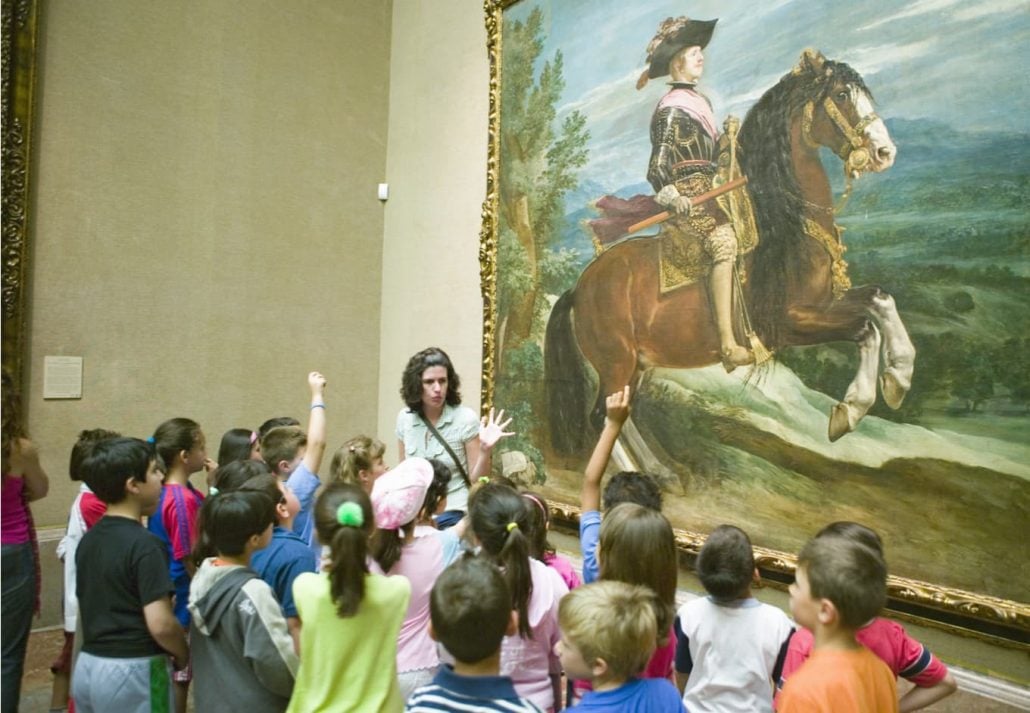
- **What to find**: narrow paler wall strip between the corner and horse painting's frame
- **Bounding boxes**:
[378,0,489,449]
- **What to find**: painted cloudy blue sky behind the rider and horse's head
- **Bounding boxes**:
[505,0,1030,191]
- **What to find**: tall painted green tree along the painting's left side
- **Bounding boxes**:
[495,8,589,479]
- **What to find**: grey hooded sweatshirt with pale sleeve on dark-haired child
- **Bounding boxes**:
[190,558,300,713]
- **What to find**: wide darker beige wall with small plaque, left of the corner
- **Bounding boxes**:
[26,0,393,525]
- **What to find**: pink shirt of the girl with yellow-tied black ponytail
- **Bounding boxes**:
[501,557,569,711]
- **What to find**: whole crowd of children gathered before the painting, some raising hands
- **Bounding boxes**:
[26,367,955,713]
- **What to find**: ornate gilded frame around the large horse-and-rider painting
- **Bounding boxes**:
[479,0,1030,651]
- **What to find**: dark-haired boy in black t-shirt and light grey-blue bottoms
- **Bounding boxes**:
[72,438,190,713]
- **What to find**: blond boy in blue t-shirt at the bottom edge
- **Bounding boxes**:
[558,581,686,713]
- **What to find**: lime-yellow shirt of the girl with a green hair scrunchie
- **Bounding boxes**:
[286,572,411,713]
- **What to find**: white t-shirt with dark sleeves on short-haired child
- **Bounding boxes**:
[674,597,794,713]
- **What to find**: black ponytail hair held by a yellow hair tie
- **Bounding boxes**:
[469,482,533,638]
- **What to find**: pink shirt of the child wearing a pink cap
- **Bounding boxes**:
[369,525,444,674]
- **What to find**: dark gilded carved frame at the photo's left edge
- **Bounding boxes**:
[2,0,38,382]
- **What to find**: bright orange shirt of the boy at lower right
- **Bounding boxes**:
[777,647,898,713]
